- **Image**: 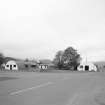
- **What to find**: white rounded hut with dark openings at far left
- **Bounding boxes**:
[5,60,18,70]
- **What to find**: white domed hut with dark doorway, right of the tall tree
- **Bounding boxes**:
[77,62,97,71]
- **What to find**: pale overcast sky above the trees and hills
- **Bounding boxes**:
[0,0,105,61]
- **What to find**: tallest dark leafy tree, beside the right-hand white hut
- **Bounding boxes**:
[62,47,80,69]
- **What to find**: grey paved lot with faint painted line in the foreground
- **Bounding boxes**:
[0,72,105,105]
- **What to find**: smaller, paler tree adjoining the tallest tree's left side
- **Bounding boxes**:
[53,51,63,69]
